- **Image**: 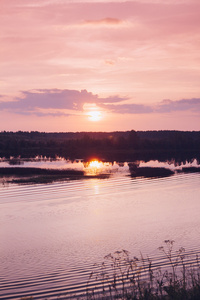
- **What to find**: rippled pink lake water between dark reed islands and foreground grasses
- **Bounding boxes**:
[0,162,200,299]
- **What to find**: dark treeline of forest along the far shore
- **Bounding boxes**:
[0,130,200,161]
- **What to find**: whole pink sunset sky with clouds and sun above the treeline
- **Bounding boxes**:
[0,0,200,132]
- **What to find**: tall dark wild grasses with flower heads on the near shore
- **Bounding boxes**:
[85,240,200,300]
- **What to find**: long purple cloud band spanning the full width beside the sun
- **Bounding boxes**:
[0,89,200,116]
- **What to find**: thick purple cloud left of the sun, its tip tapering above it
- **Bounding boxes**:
[0,89,127,115]
